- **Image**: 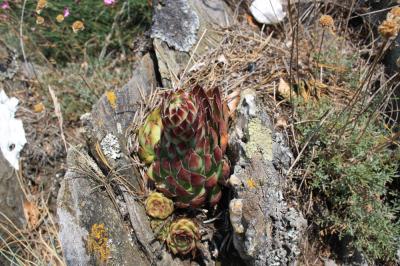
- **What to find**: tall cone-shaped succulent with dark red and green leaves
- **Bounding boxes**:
[148,87,230,208]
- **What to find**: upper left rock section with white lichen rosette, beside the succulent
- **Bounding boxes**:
[82,54,157,189]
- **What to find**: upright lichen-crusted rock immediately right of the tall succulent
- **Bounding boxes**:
[229,90,307,265]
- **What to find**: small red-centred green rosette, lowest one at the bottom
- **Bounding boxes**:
[166,218,200,255]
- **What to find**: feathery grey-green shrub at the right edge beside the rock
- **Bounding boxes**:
[297,96,400,261]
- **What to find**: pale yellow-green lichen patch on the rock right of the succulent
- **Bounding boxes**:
[245,118,272,161]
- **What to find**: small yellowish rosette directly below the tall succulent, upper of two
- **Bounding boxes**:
[144,192,174,220]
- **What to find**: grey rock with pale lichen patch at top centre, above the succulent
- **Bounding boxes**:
[152,0,233,87]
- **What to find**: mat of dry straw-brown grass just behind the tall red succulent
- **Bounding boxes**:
[181,26,356,107]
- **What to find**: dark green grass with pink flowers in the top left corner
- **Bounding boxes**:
[0,0,151,64]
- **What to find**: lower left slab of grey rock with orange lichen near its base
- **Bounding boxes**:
[57,148,150,265]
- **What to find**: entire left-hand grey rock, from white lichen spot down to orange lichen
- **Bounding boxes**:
[57,55,192,265]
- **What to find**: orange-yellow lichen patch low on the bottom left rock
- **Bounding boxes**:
[87,224,110,262]
